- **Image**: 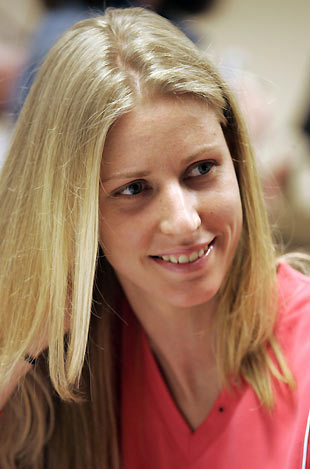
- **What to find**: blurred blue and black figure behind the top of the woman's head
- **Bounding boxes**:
[11,0,219,115]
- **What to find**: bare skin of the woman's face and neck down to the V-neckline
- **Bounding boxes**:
[100,98,242,429]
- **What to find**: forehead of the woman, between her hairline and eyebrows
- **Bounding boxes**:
[103,97,225,166]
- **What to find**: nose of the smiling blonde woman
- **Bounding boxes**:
[159,184,201,235]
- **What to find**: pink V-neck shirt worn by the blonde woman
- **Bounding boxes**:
[121,264,310,469]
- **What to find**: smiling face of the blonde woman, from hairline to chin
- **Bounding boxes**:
[100,97,242,307]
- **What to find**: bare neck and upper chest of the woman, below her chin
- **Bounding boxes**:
[123,286,219,428]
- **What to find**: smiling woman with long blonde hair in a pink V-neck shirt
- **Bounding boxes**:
[0,9,310,469]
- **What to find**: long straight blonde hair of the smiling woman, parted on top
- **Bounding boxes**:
[0,8,293,469]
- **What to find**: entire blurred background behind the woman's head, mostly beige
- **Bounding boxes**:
[0,0,310,251]
